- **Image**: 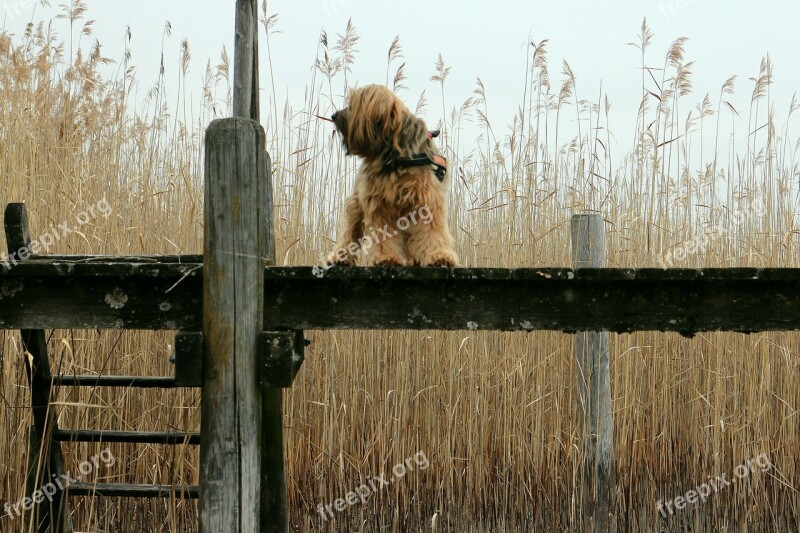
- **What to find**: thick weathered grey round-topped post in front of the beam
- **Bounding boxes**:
[199,118,272,533]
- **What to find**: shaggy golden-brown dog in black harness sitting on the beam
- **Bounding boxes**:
[328,85,458,267]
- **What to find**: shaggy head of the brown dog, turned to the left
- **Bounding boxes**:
[331,85,429,165]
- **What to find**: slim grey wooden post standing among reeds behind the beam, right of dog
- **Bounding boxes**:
[572,215,616,532]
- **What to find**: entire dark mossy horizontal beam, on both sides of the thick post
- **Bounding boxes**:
[0,258,800,335]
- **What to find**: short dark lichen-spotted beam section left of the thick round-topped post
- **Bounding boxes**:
[0,261,202,330]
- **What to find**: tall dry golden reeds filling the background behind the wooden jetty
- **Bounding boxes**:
[0,5,800,532]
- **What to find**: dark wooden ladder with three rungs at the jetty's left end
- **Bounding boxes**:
[4,203,200,533]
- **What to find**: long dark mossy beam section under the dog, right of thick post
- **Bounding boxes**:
[265,267,800,335]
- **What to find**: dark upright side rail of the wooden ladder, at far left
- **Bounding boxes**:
[0,203,72,533]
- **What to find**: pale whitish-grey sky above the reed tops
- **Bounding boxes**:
[0,0,800,156]
